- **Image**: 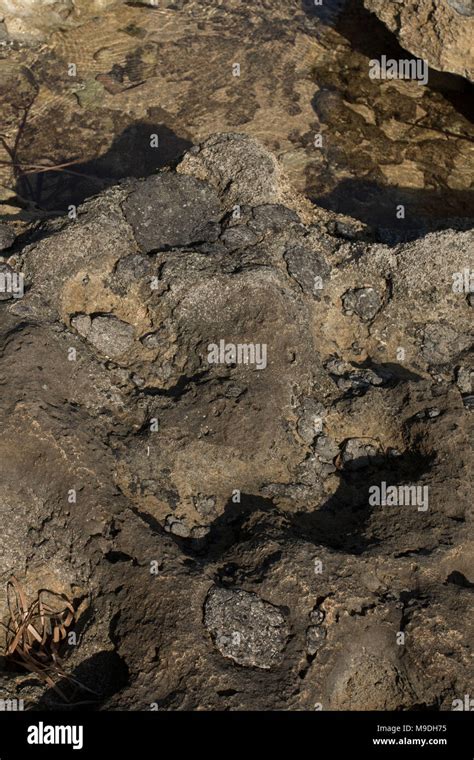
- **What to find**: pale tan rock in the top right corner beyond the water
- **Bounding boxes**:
[364,0,474,82]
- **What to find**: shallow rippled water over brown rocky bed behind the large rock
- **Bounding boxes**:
[0,0,474,238]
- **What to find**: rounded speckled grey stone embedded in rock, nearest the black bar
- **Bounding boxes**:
[204,586,289,670]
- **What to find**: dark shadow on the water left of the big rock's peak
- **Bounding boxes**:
[15,122,192,215]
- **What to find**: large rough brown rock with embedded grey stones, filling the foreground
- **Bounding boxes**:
[0,134,474,710]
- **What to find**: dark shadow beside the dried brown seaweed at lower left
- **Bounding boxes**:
[32,651,129,711]
